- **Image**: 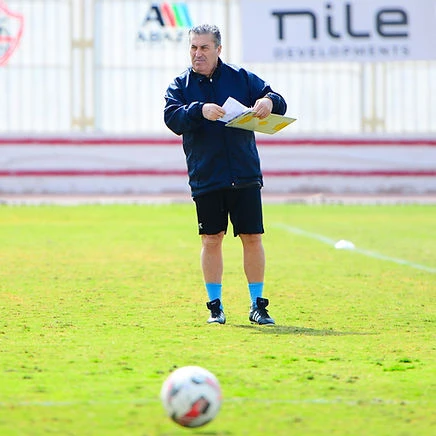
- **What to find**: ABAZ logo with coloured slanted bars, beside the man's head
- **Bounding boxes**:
[137,2,192,43]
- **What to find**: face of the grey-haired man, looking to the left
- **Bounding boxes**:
[190,33,221,76]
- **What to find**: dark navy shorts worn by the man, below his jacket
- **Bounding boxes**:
[194,185,264,236]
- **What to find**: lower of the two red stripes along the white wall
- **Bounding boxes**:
[0,169,436,177]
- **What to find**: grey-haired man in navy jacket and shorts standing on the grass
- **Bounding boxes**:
[164,24,286,325]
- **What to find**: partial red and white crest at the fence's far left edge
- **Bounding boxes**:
[0,0,24,66]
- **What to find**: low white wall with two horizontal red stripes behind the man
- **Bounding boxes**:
[0,135,436,194]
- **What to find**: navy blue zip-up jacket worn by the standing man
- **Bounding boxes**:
[164,59,286,198]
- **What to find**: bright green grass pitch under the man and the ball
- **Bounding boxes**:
[0,204,436,436]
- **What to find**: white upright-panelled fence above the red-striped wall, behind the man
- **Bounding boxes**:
[0,0,436,135]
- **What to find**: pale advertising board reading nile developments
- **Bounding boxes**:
[241,0,436,62]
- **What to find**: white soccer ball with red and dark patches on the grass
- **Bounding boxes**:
[160,366,222,427]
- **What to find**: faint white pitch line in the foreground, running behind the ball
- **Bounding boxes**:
[0,397,416,409]
